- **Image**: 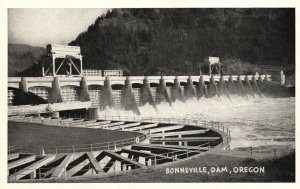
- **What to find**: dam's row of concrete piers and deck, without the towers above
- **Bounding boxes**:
[8,75,282,118]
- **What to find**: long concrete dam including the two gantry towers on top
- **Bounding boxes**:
[8,44,290,116]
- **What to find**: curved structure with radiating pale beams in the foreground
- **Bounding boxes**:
[8,117,230,182]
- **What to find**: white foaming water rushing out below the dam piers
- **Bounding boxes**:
[100,96,295,149]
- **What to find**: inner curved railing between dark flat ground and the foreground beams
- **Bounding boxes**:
[8,134,148,155]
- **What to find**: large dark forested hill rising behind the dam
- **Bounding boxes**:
[70,8,295,75]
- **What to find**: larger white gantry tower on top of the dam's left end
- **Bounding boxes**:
[42,44,82,77]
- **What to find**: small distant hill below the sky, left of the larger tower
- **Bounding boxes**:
[8,44,45,77]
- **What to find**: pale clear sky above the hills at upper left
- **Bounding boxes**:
[8,8,108,47]
